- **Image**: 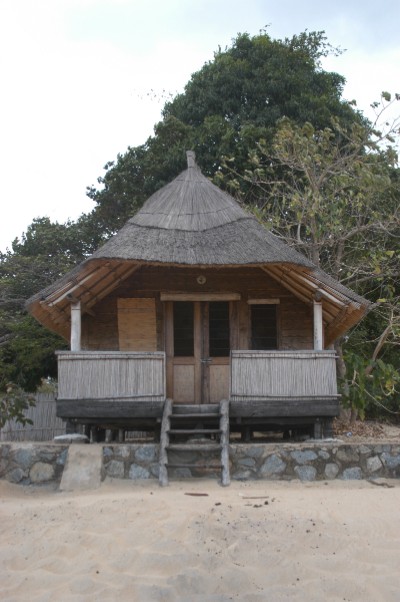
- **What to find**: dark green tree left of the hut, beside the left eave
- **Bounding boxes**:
[0,216,101,391]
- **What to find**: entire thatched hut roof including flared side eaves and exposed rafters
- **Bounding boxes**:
[27,152,368,337]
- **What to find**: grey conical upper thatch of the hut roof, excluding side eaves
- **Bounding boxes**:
[89,153,312,267]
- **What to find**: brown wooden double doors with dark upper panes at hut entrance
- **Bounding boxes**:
[167,301,230,403]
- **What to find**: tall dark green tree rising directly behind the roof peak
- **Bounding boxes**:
[88,32,362,223]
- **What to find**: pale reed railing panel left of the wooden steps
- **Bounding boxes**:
[58,352,165,401]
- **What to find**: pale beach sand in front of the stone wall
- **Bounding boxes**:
[0,480,400,602]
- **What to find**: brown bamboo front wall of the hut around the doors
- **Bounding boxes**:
[82,266,313,351]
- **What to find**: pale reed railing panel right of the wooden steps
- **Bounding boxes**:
[231,351,337,401]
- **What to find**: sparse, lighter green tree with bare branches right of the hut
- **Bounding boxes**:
[223,93,400,420]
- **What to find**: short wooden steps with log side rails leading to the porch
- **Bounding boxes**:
[159,399,230,486]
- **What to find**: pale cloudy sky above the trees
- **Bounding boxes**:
[0,0,400,252]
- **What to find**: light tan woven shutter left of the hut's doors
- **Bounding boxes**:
[118,298,157,351]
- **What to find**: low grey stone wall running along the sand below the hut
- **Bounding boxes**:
[0,441,400,485]
